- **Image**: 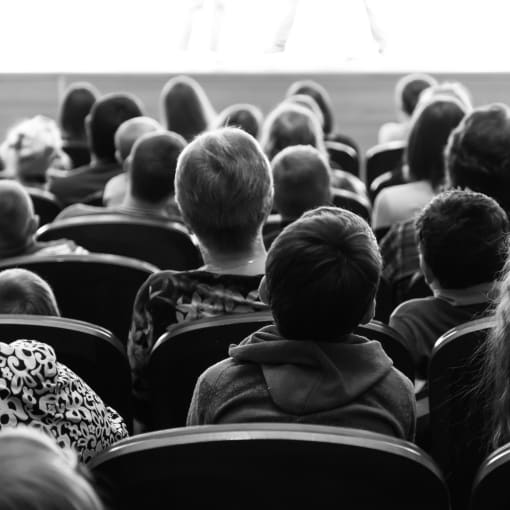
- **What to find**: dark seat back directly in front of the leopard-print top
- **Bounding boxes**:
[0,315,133,429]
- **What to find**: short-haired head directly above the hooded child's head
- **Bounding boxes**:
[271,145,331,219]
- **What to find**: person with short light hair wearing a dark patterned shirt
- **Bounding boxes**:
[128,128,273,420]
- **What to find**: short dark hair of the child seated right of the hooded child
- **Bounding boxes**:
[416,190,509,289]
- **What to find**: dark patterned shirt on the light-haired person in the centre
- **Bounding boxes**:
[128,269,268,400]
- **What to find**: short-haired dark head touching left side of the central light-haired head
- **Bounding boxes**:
[128,131,186,204]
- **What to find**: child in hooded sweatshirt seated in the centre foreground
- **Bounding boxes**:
[187,207,416,440]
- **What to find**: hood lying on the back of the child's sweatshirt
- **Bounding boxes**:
[229,325,393,415]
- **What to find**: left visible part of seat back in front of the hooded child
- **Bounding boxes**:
[148,312,273,429]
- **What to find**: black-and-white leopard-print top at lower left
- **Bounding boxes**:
[0,340,128,462]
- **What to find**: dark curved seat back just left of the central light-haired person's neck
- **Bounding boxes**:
[37,213,202,271]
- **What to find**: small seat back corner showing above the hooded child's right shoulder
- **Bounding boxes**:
[354,320,414,382]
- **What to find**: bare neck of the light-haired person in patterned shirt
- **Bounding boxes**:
[201,235,266,276]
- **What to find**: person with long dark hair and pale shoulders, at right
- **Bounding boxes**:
[372,97,466,230]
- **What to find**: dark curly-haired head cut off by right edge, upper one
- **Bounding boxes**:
[446,104,510,214]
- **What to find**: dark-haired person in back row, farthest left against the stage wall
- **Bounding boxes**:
[58,82,99,168]
